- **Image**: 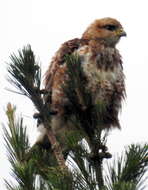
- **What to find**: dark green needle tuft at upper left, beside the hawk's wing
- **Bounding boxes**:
[8,45,41,97]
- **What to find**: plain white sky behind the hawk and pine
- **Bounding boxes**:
[0,0,148,190]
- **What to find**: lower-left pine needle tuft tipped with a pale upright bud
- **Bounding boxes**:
[3,103,30,163]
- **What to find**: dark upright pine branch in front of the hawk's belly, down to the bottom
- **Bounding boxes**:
[63,55,111,188]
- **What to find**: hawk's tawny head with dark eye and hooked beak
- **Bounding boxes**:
[82,18,126,46]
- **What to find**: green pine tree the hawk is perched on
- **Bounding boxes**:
[4,45,148,190]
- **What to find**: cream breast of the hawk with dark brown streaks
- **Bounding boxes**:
[74,46,124,103]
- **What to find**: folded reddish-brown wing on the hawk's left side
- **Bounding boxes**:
[44,38,86,109]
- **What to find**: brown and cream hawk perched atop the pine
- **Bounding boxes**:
[37,18,126,154]
